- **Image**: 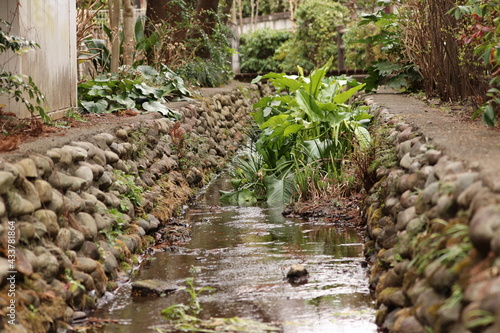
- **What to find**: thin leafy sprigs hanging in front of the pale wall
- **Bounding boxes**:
[0,19,51,122]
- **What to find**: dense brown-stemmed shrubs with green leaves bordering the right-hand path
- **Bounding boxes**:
[361,0,500,126]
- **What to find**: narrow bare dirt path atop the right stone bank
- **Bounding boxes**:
[370,89,500,191]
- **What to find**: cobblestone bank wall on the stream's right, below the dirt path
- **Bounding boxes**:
[363,97,500,333]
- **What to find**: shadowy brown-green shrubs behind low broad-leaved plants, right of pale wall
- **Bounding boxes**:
[79,0,233,86]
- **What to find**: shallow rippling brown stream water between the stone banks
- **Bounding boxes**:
[91,172,377,333]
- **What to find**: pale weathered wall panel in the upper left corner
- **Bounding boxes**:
[0,0,77,117]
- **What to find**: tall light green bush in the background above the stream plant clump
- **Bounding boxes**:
[276,0,349,72]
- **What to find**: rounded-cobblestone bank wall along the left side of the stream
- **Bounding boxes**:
[0,85,261,333]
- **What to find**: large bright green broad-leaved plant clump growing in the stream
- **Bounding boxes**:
[222,59,371,204]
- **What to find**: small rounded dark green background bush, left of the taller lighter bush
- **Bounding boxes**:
[240,30,291,73]
